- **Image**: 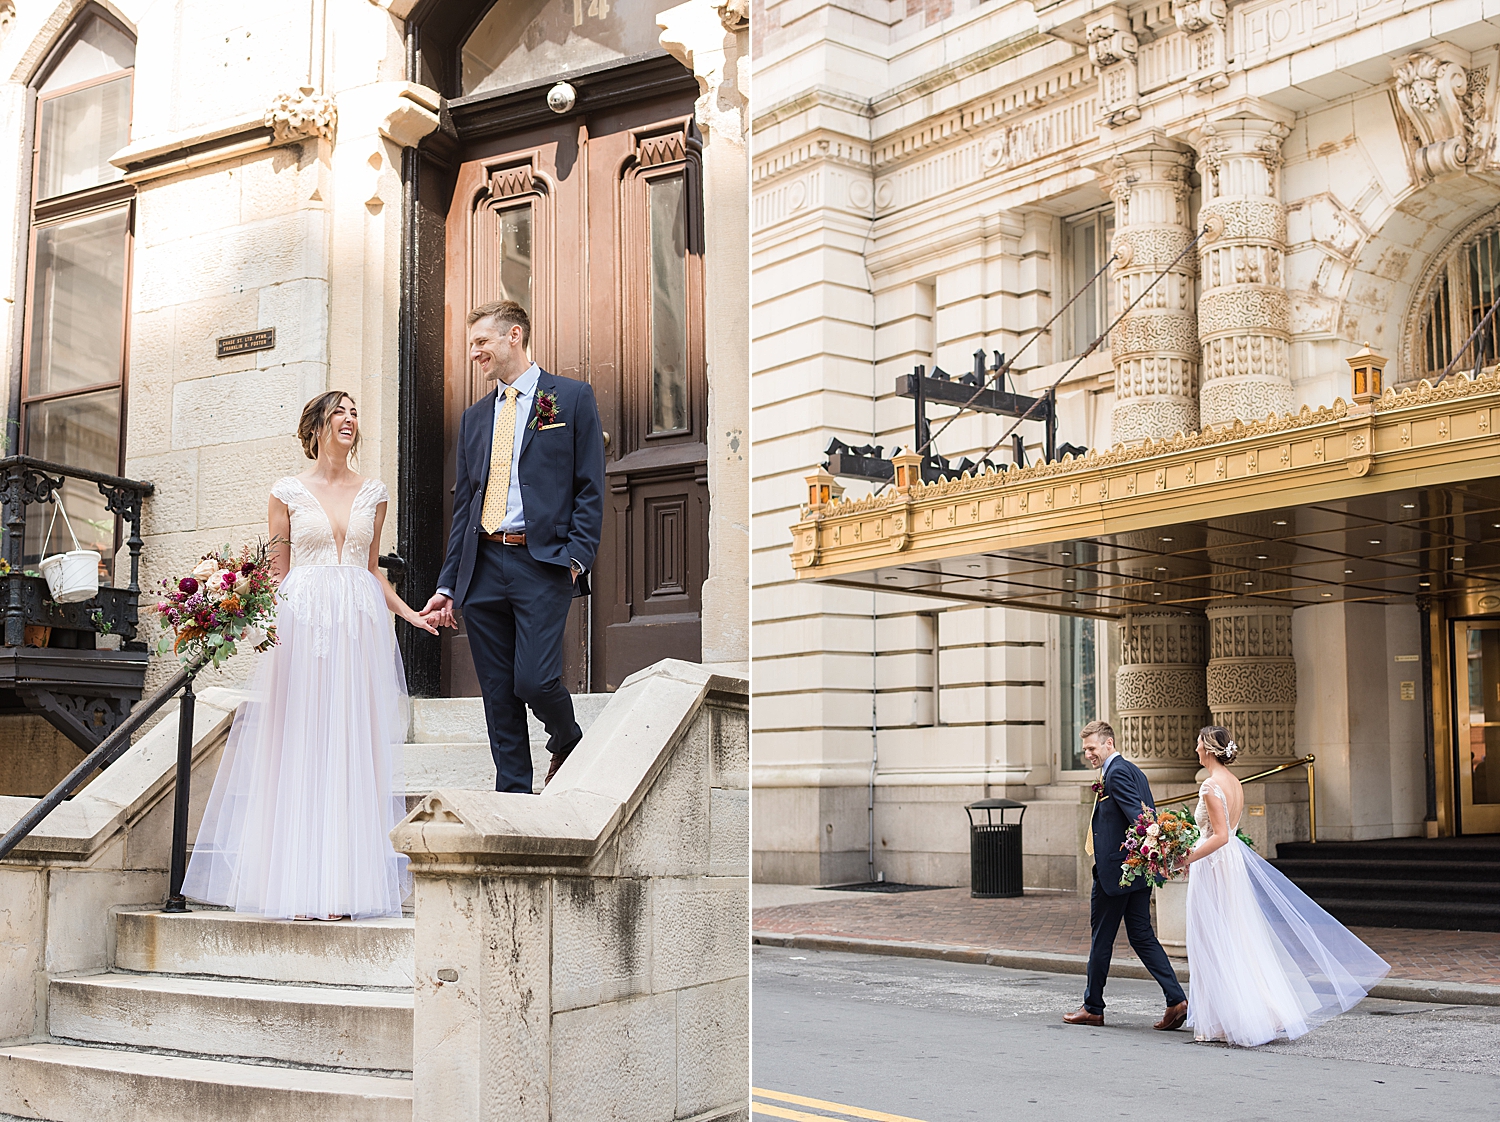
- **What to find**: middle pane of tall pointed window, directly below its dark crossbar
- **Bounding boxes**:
[27,207,128,396]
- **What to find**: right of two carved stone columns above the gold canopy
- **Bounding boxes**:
[1194,117,1292,428]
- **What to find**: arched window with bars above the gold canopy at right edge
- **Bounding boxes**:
[1416,215,1500,378]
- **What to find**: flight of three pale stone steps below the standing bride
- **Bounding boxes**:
[0,911,414,1122]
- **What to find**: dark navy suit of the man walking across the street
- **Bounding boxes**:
[1083,753,1187,1013]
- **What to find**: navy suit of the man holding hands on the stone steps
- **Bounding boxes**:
[438,371,605,792]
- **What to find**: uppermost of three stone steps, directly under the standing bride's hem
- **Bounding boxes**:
[114,909,416,989]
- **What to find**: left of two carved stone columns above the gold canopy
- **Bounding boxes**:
[1110,141,1199,444]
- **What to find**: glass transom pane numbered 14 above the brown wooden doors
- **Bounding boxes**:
[464,0,681,95]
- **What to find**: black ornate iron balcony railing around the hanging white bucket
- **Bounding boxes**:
[0,456,156,651]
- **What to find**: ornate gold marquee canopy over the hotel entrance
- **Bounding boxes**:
[792,366,1500,618]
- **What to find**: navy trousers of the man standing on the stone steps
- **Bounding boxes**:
[461,539,584,795]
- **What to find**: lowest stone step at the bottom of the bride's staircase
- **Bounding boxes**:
[0,1044,411,1122]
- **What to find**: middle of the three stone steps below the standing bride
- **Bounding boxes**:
[47,974,413,1073]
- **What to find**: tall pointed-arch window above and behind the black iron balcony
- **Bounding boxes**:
[21,12,135,579]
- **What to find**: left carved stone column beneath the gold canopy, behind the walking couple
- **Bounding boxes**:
[1115,611,1209,783]
